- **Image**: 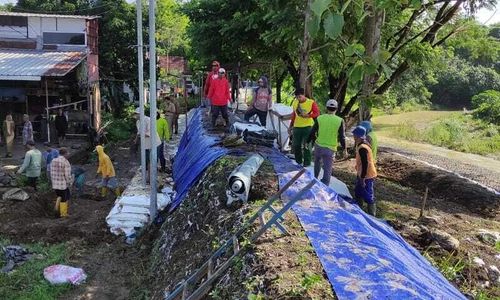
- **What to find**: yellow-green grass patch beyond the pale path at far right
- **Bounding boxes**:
[392,114,500,155]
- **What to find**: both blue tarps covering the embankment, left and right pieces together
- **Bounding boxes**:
[172,110,465,300]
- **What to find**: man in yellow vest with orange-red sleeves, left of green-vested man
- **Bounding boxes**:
[288,88,319,167]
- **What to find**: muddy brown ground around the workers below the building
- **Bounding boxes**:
[0,143,147,299]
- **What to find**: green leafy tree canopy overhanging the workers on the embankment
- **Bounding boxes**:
[184,0,494,115]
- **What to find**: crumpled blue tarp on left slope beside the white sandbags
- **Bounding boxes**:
[170,108,228,211]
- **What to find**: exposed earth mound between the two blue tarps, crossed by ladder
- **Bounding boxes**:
[146,156,333,299]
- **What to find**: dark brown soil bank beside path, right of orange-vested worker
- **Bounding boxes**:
[377,152,500,218]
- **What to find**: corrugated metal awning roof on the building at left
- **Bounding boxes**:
[0,49,87,81]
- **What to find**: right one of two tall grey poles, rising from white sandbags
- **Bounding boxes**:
[149,0,158,221]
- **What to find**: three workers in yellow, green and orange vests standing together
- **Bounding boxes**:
[288,88,378,216]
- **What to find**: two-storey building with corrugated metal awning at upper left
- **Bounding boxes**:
[0,12,100,140]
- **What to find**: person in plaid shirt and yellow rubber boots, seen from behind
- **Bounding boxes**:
[50,147,74,218]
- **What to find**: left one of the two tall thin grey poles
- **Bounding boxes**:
[135,0,146,185]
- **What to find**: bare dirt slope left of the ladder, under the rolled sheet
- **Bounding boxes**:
[148,157,277,299]
